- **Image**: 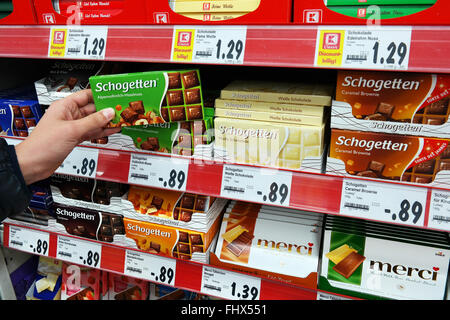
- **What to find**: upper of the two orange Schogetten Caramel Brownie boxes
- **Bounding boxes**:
[331,71,450,138]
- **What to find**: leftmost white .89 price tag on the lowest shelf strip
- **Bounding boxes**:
[8,225,50,256]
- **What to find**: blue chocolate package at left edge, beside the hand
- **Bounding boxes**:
[0,99,43,138]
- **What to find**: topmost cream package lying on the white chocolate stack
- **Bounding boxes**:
[220,80,334,106]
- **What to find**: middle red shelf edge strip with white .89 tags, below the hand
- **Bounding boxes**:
[7,137,450,232]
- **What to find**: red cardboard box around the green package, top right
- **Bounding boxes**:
[294,0,450,25]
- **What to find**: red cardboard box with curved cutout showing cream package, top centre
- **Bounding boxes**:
[148,0,292,25]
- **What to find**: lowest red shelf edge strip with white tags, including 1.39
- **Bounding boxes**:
[3,222,355,300]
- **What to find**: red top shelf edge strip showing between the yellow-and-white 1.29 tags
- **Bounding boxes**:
[0,25,450,73]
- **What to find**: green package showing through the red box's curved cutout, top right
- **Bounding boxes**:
[328,5,431,19]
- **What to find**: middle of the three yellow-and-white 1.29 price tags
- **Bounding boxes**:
[171,26,247,64]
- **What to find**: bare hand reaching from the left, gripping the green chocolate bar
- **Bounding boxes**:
[16,90,120,184]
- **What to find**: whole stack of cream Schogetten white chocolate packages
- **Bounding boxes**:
[214,80,334,171]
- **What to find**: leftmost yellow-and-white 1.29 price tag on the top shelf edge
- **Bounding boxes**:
[48,25,108,60]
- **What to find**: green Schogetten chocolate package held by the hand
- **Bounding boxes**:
[89,70,204,127]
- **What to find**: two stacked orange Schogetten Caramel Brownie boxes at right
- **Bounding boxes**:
[327,71,450,185]
